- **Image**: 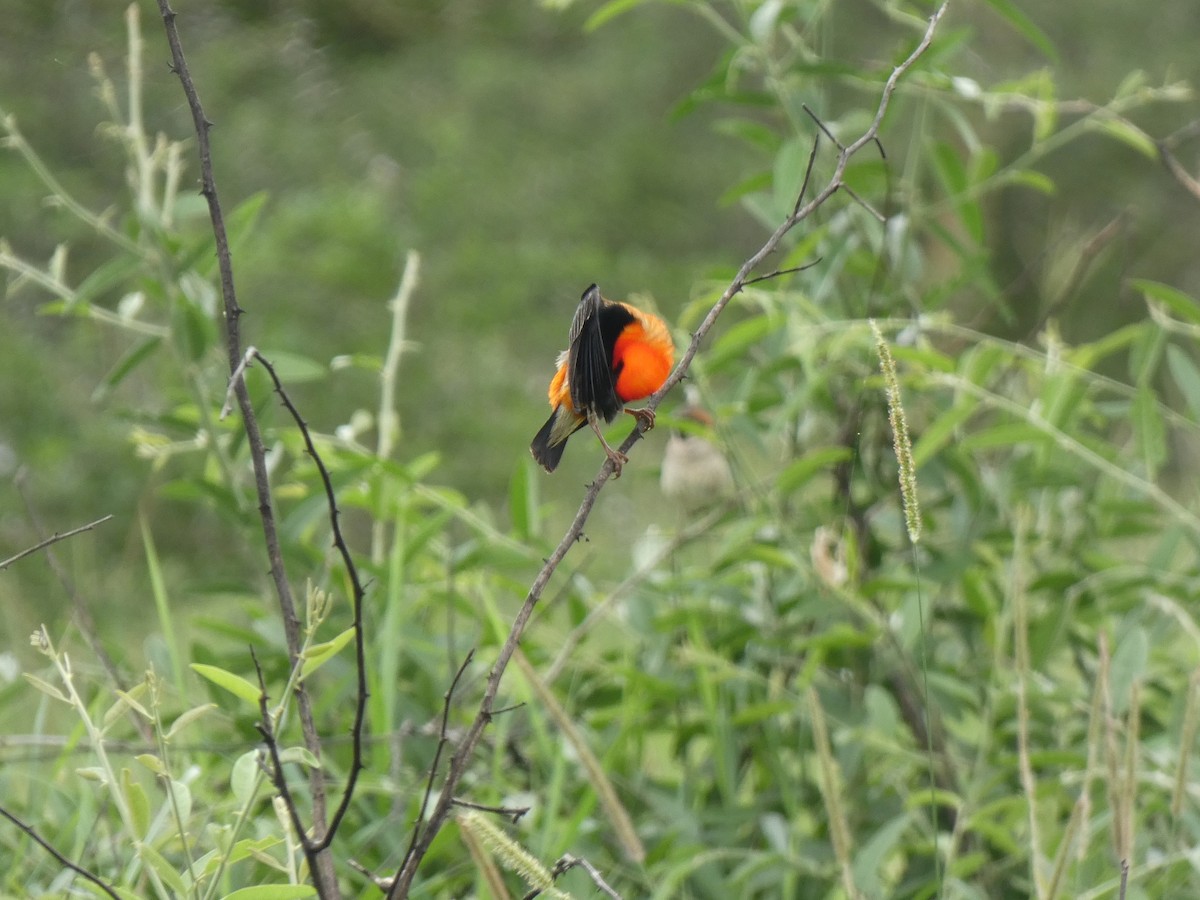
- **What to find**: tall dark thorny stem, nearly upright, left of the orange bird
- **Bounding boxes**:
[158,0,340,900]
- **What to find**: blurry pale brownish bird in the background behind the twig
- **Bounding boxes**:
[659,385,736,511]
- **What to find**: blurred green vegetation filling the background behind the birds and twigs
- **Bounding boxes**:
[0,0,1200,898]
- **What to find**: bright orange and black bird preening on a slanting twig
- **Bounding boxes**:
[529,284,674,478]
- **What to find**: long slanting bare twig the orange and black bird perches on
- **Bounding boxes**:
[384,7,949,900]
